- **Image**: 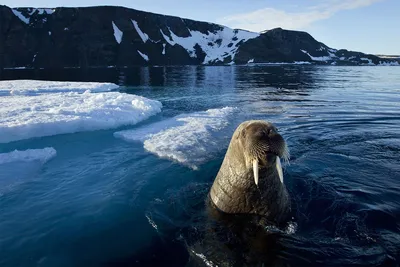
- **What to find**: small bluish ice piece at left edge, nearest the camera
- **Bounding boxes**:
[0,147,57,164]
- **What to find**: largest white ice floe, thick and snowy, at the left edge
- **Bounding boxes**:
[0,91,162,143]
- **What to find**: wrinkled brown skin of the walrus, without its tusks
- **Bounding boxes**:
[209,121,290,224]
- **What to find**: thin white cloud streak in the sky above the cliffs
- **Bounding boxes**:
[217,0,384,32]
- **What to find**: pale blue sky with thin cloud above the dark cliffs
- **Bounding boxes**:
[0,0,400,55]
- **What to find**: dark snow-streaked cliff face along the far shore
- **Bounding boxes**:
[0,6,394,68]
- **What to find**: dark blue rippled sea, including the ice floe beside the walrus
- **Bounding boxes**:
[0,65,400,267]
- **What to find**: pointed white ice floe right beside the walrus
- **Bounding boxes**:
[114,107,236,169]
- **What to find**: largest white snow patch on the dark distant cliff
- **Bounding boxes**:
[160,27,260,64]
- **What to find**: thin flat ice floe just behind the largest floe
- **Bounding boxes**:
[0,79,119,96]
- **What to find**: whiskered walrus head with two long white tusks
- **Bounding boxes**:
[236,120,289,185]
